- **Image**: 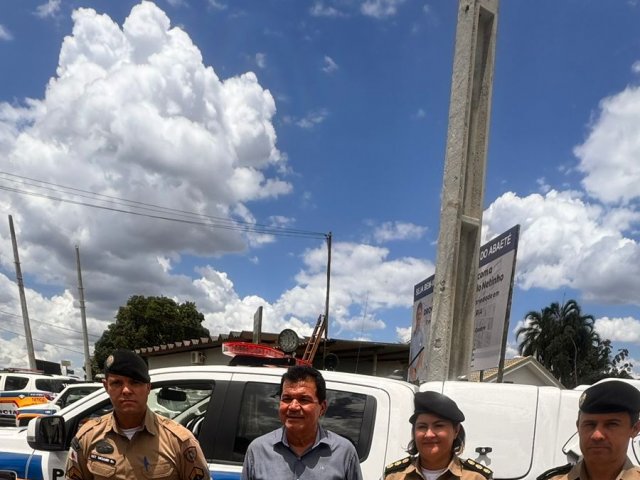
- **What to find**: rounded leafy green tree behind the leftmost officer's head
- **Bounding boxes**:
[92,295,209,372]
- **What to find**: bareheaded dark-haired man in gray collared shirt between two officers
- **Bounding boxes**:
[242,366,362,480]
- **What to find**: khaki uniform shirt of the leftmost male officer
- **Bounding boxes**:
[65,409,210,480]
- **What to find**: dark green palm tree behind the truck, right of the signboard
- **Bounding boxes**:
[516,300,632,388]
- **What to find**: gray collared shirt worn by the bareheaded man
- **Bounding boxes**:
[242,427,362,480]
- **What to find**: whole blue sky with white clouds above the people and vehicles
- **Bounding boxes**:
[0,0,640,371]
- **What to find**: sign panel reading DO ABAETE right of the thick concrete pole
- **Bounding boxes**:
[471,225,520,370]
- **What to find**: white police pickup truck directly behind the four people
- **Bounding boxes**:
[0,366,632,480]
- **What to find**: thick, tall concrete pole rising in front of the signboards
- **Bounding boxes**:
[426,0,499,380]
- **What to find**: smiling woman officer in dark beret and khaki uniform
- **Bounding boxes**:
[384,392,493,480]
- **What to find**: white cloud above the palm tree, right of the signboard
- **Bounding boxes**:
[483,190,640,305]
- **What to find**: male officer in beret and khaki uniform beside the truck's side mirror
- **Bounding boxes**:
[66,350,210,480]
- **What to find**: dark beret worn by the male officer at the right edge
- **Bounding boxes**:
[579,380,640,414]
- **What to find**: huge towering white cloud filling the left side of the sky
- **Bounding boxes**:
[0,1,292,368]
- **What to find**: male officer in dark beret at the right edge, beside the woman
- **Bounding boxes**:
[538,380,640,480]
